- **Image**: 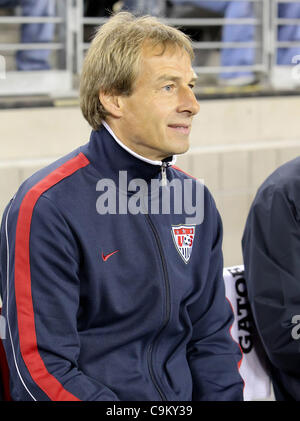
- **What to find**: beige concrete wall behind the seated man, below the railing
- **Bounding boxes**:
[0,97,300,266]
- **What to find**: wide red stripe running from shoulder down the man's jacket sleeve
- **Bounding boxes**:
[15,153,89,401]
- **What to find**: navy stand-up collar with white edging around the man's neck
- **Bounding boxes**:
[84,123,176,182]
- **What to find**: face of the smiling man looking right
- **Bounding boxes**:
[108,46,199,160]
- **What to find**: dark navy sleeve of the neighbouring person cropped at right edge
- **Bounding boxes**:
[242,184,300,400]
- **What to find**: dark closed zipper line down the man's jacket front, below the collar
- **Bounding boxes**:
[145,214,171,401]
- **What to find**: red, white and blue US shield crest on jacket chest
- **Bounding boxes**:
[172,225,195,263]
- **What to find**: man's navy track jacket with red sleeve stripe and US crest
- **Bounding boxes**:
[0,126,243,401]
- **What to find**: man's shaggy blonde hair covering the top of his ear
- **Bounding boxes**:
[80,12,194,130]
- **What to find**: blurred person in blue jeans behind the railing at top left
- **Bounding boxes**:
[0,0,55,70]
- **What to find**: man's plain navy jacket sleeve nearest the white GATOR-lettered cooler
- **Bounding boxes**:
[187,194,244,401]
